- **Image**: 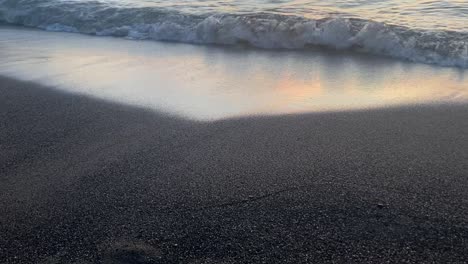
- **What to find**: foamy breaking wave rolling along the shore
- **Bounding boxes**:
[0,0,468,68]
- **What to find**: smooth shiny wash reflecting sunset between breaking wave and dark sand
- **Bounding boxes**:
[0,27,468,120]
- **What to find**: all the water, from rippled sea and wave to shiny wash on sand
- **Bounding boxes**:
[0,0,468,120]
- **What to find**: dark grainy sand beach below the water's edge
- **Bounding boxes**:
[0,75,468,263]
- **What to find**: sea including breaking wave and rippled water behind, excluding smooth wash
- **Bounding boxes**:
[0,0,468,68]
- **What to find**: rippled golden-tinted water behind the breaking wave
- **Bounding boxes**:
[100,0,468,31]
